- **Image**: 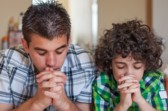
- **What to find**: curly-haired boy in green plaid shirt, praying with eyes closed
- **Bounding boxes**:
[93,20,168,111]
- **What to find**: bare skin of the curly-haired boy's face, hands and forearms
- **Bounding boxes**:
[112,55,156,111]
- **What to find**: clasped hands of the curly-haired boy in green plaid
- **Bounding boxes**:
[118,75,142,110]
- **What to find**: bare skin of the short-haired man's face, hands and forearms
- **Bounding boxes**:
[0,34,91,111]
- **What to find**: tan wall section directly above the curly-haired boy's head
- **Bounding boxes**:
[98,0,150,36]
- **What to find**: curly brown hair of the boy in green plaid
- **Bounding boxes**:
[95,19,163,74]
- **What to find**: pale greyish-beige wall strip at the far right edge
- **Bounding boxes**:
[153,0,168,64]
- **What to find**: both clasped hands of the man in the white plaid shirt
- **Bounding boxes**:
[35,68,68,110]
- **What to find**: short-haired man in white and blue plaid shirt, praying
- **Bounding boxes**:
[0,0,96,111]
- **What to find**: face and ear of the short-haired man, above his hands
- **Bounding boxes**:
[22,34,69,72]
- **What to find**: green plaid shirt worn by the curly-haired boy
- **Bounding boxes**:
[93,71,168,111]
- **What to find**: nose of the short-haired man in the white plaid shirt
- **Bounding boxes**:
[46,53,56,68]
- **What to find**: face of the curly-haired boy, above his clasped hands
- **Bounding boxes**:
[112,55,145,81]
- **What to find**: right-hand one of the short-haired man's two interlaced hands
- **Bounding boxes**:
[36,69,69,110]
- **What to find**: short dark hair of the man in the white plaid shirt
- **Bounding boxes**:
[22,0,71,43]
